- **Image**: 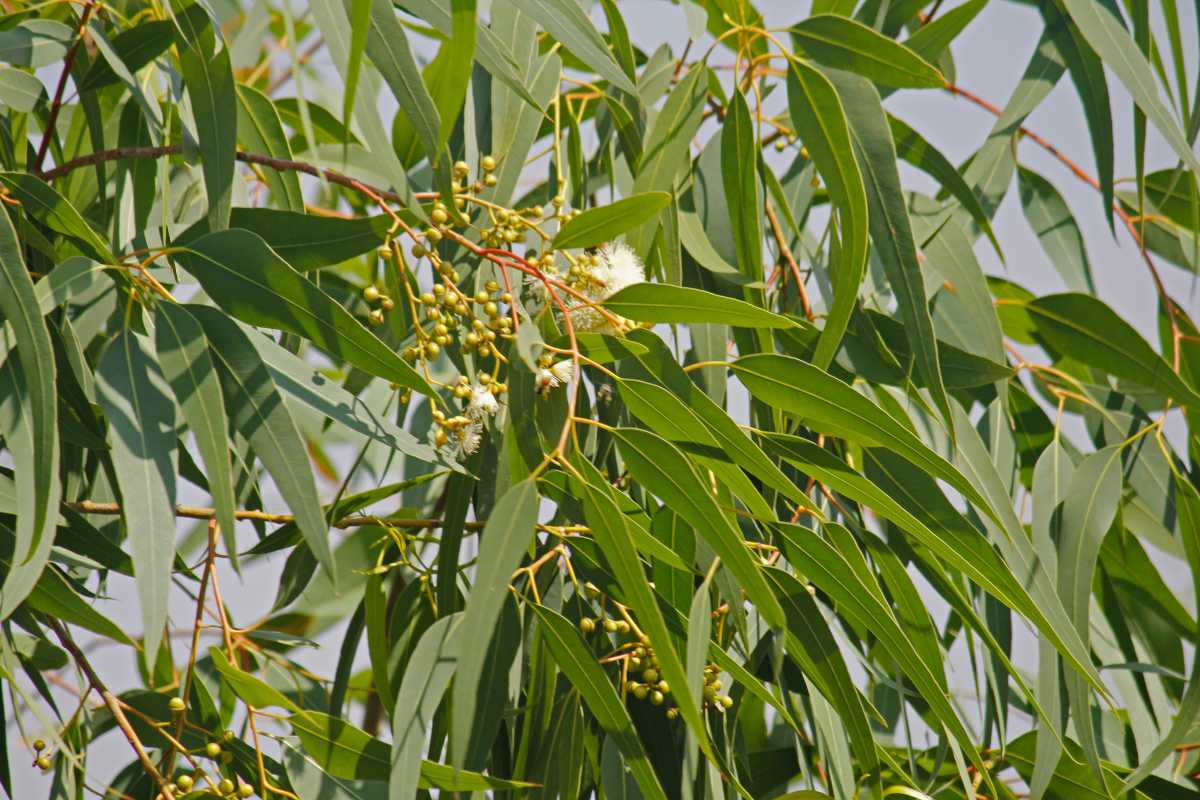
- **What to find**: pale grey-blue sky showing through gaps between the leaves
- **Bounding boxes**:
[6,0,1198,798]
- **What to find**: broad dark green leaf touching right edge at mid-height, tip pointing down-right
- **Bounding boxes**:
[1025,294,1200,407]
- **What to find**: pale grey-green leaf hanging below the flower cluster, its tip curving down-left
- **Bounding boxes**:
[450,479,538,764]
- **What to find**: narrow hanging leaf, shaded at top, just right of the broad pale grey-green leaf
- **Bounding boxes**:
[155,302,238,566]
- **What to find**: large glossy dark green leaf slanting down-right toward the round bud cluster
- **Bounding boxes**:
[175,229,433,395]
